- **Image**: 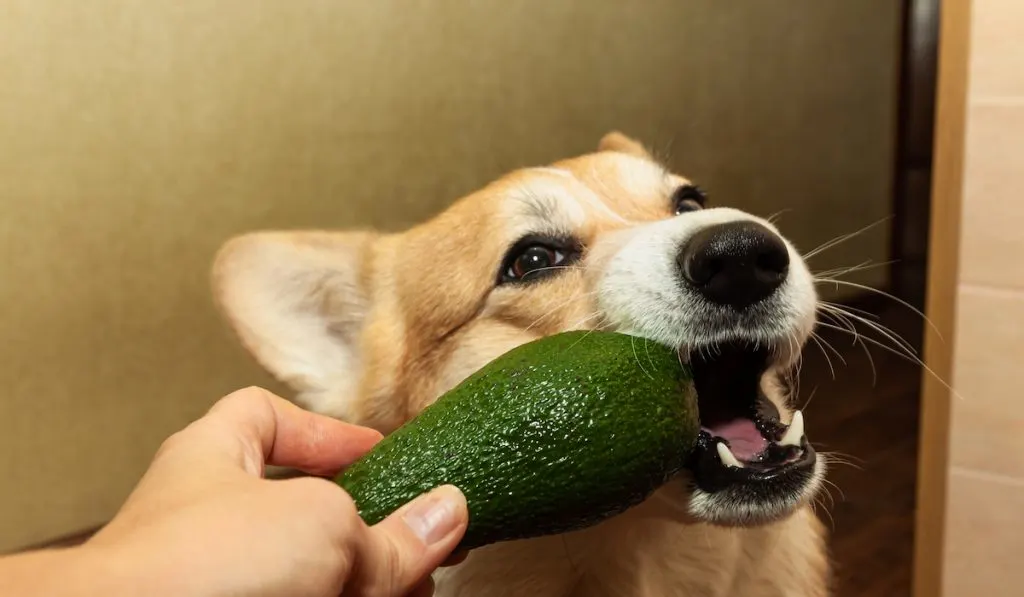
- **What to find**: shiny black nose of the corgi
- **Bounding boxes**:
[676,222,790,309]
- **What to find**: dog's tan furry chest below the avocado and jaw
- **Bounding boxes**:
[434,497,829,597]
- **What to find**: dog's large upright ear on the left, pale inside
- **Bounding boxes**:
[212,231,375,419]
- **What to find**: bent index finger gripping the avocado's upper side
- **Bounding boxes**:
[200,388,381,475]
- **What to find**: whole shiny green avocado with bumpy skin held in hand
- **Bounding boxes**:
[336,331,699,549]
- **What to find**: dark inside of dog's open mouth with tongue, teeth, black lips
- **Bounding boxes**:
[690,343,816,500]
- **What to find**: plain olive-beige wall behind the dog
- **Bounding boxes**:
[0,0,898,550]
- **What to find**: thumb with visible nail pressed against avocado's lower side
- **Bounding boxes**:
[346,485,469,597]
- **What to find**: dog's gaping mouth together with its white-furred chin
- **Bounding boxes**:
[663,341,824,526]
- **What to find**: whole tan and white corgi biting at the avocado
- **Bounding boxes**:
[212,132,830,597]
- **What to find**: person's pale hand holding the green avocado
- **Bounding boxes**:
[0,388,468,597]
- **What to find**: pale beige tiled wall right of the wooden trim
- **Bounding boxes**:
[940,0,1024,597]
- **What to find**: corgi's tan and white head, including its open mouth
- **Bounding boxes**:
[214,133,823,524]
